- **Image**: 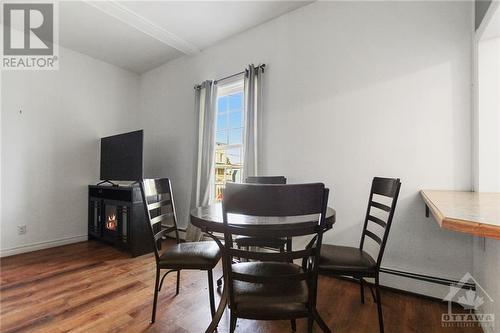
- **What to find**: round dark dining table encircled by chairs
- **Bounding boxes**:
[191,202,335,333]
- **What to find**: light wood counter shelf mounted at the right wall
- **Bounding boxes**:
[420,190,500,239]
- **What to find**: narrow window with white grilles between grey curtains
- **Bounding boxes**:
[212,79,245,201]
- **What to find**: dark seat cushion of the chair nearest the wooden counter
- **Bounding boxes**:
[319,245,376,274]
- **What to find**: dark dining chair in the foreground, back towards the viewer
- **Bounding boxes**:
[222,183,330,333]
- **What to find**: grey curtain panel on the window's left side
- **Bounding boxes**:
[186,81,217,241]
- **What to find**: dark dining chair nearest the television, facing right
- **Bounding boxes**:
[140,178,221,323]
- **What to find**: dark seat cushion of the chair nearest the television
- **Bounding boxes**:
[160,241,221,270]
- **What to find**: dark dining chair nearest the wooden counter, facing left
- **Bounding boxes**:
[318,177,401,333]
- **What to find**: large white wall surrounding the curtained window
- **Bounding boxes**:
[141,2,473,297]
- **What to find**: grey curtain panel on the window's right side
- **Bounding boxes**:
[243,65,264,179]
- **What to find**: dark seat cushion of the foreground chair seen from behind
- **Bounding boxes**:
[232,262,308,320]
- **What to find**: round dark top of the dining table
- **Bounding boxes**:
[191,202,335,233]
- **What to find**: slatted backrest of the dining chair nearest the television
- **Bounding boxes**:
[141,178,180,262]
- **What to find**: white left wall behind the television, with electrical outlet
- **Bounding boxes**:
[0,47,139,255]
